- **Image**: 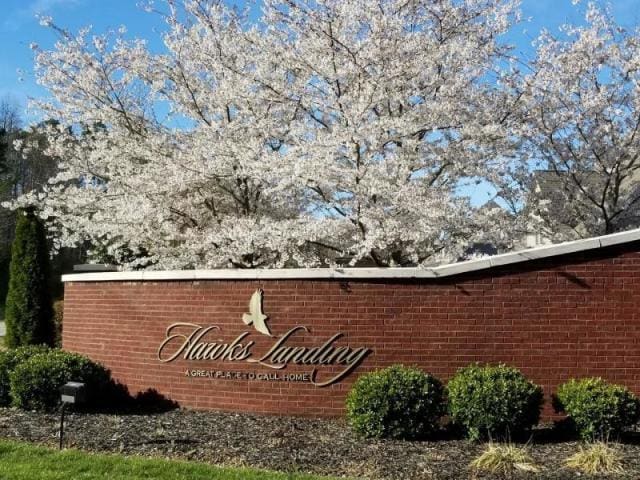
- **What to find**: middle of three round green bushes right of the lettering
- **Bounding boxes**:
[447,365,544,440]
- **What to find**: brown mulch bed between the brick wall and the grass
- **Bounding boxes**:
[0,409,640,480]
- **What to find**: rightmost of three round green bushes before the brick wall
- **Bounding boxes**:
[553,378,640,440]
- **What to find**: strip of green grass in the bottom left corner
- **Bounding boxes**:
[0,441,340,480]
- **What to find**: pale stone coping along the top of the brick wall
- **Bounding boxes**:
[62,228,640,282]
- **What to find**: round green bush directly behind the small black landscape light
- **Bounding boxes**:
[9,350,112,411]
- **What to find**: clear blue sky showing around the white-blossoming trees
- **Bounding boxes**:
[0,0,640,205]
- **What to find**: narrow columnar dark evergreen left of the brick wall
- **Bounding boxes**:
[5,210,54,347]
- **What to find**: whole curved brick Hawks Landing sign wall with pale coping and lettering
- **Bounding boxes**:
[63,231,640,416]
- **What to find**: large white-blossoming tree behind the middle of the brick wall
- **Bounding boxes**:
[16,0,517,268]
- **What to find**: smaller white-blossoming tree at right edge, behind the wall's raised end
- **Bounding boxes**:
[517,2,640,240]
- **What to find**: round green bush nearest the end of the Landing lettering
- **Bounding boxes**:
[347,365,444,439]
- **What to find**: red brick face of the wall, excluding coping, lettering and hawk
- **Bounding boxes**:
[63,243,640,416]
